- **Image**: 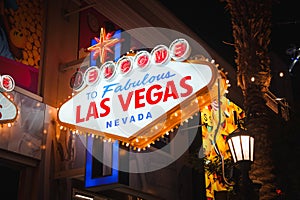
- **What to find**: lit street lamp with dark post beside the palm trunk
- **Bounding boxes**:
[226,126,258,200]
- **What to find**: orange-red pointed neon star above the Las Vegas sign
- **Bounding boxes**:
[87,28,123,63]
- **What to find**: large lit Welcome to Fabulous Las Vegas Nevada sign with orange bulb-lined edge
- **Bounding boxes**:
[58,38,224,148]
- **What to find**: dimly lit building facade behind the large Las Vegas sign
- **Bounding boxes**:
[0,0,285,200]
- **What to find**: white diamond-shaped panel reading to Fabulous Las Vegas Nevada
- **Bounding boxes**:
[58,61,215,138]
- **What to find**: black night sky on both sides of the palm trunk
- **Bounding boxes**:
[161,0,300,199]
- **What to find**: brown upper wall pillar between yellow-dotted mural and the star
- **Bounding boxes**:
[42,1,79,107]
